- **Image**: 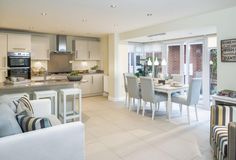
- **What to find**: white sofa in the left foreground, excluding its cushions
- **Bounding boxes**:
[0,99,85,160]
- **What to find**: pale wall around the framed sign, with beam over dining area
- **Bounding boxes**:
[120,7,236,90]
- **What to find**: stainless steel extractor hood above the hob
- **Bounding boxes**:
[55,35,71,53]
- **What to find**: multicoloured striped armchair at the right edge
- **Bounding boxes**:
[210,105,236,160]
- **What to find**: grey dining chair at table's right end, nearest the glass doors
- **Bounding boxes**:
[171,78,202,124]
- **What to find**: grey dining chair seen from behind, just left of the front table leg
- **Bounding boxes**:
[140,77,167,120]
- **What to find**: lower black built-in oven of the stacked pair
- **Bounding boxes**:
[7,67,31,79]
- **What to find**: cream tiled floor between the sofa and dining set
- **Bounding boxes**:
[83,97,213,160]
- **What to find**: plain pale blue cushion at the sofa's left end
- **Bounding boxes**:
[0,103,22,137]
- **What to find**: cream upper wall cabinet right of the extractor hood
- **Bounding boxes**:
[74,40,101,60]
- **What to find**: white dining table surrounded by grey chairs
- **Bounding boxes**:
[154,83,189,120]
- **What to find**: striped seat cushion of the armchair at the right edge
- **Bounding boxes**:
[212,126,228,160]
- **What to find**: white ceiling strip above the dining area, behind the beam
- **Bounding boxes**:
[127,26,217,43]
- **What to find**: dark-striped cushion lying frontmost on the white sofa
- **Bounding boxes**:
[16,111,52,132]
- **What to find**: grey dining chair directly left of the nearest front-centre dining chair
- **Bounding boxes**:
[126,75,142,114]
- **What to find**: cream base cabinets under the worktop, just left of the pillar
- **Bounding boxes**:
[79,74,103,96]
